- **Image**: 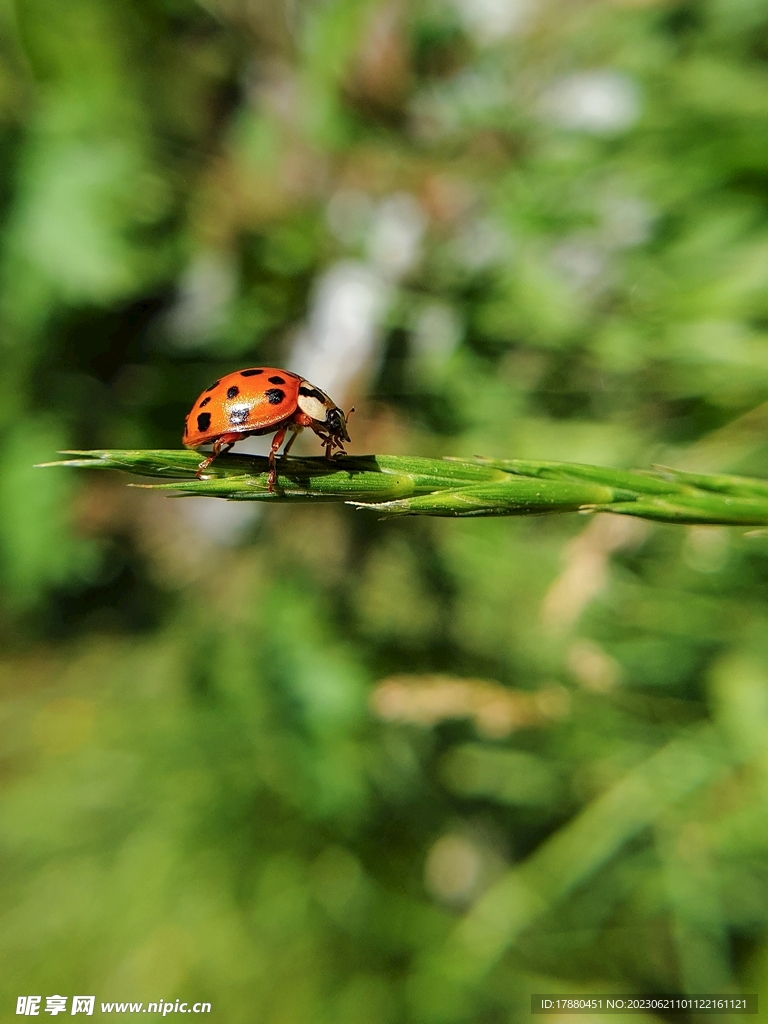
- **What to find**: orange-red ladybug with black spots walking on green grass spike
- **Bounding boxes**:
[183,367,353,490]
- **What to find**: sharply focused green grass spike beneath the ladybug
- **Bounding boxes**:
[44,451,768,526]
